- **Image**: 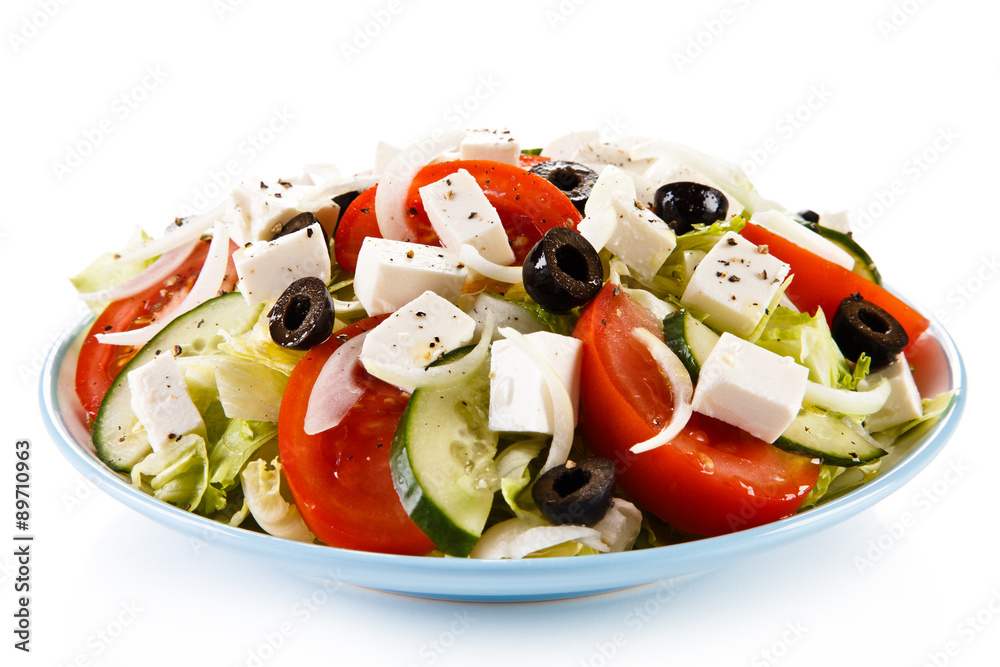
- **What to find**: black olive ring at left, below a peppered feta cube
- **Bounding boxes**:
[268,277,333,350]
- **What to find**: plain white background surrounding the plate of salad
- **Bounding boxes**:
[0,0,1000,667]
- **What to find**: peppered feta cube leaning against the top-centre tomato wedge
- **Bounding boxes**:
[420,169,514,265]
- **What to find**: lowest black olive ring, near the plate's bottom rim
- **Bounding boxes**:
[531,456,615,526]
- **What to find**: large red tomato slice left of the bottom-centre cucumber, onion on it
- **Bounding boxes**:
[278,315,434,556]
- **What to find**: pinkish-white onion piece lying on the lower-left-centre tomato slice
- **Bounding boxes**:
[303,333,367,435]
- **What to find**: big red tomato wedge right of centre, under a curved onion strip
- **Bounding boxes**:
[573,285,820,535]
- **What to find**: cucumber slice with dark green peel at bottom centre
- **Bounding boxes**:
[390,346,497,557]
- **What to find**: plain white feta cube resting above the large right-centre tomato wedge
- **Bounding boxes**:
[691,332,809,442]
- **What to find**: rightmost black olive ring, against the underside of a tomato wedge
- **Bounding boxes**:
[830,293,910,370]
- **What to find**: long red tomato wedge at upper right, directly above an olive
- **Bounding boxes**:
[741,222,930,350]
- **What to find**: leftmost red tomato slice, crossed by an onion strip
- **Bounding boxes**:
[76,239,237,420]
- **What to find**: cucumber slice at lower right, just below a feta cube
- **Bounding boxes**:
[774,410,886,468]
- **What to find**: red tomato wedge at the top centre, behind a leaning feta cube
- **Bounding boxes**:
[334,160,583,271]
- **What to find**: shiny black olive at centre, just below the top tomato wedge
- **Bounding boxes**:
[521,227,604,312]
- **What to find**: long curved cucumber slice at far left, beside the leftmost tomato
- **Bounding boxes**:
[93,292,264,473]
